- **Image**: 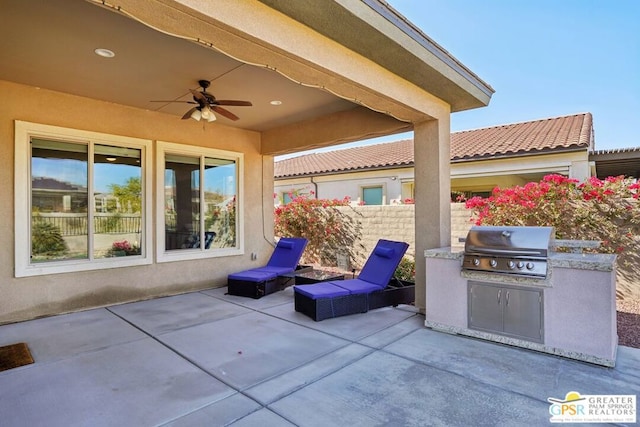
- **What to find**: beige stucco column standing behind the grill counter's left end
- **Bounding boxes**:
[413,118,451,313]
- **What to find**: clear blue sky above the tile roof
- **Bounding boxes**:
[278,0,640,159]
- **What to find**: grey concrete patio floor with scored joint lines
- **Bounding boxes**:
[0,288,640,427]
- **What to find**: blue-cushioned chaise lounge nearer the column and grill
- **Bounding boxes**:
[294,239,415,321]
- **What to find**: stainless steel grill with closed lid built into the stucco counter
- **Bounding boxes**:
[462,226,555,277]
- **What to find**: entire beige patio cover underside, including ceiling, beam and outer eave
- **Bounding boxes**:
[0,0,493,139]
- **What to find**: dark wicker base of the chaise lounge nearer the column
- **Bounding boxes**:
[294,279,415,322]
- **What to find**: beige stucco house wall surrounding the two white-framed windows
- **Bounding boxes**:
[0,81,273,323]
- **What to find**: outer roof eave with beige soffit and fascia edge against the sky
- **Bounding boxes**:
[258,0,494,112]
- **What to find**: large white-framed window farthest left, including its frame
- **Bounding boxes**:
[15,121,151,277]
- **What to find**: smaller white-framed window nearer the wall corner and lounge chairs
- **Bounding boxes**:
[157,142,242,262]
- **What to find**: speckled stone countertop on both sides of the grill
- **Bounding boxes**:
[424,246,616,271]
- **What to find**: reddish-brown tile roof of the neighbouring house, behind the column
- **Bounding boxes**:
[274,113,593,178]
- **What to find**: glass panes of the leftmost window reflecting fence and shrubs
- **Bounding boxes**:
[31,138,142,263]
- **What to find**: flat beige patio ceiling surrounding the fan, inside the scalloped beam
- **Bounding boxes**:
[0,0,356,131]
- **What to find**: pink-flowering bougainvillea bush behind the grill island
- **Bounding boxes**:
[466,175,640,262]
